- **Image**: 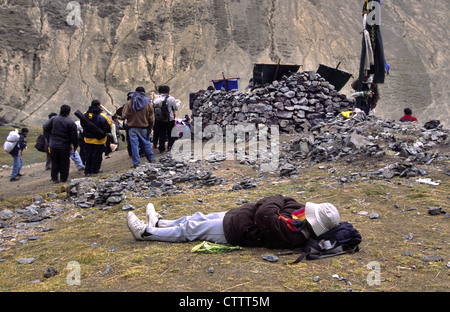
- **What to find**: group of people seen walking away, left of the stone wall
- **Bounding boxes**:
[6,86,180,183]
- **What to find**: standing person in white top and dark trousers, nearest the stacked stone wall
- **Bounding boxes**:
[153,86,180,153]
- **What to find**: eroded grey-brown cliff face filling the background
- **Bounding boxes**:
[0,0,450,125]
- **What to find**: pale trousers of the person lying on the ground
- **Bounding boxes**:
[144,212,227,244]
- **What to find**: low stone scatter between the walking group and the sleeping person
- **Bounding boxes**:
[67,153,224,208]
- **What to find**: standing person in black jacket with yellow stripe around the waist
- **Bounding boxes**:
[83,100,111,176]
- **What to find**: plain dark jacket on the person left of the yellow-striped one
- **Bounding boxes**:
[42,115,78,149]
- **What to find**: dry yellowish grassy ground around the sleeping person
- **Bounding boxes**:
[0,151,450,292]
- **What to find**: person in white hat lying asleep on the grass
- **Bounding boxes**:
[127,195,340,249]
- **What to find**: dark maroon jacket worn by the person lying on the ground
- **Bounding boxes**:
[223,195,307,249]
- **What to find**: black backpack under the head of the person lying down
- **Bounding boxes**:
[293,222,362,264]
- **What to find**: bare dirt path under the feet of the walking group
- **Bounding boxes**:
[0,150,155,198]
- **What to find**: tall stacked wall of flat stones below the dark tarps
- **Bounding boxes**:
[192,72,354,134]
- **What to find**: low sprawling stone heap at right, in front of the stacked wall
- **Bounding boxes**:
[280,113,450,169]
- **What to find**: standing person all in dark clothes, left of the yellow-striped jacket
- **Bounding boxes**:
[42,105,78,183]
